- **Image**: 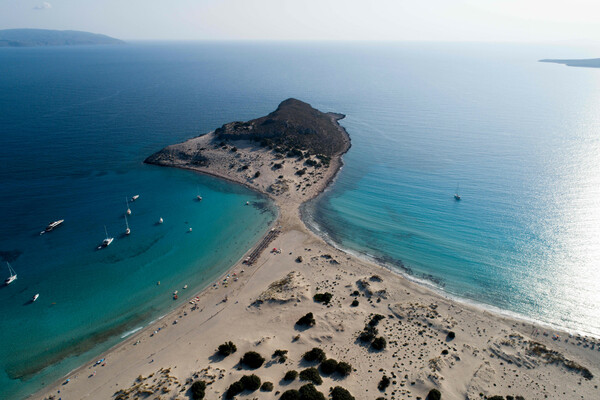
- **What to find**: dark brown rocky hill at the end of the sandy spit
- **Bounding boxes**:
[215,99,349,157]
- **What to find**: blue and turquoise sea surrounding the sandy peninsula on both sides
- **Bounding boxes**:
[0,42,600,398]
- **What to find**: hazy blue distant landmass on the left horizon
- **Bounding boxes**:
[0,29,125,47]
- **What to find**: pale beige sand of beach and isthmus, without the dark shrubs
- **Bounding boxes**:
[33,135,600,399]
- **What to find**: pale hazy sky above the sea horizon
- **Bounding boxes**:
[0,0,600,42]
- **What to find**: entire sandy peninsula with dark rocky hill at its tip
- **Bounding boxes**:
[34,99,600,400]
